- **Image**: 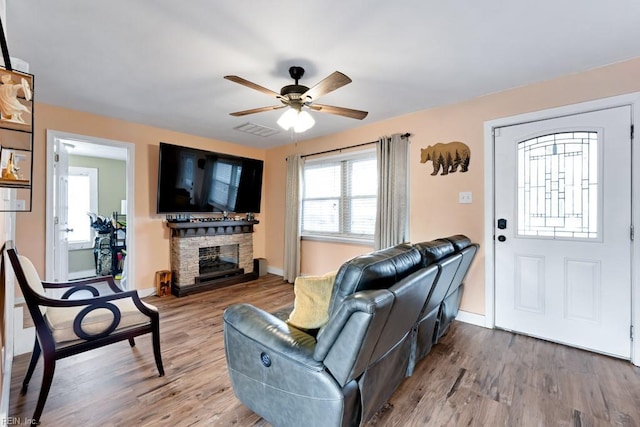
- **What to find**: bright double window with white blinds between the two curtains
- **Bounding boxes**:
[302,150,378,241]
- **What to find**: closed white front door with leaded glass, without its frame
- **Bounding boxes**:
[494,106,631,359]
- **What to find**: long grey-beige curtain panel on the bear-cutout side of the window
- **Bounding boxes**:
[374,133,409,250]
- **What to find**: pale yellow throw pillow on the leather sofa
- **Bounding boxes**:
[287,271,337,329]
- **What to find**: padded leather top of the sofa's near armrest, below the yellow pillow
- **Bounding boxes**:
[223,304,324,371]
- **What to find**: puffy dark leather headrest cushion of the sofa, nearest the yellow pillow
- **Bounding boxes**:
[329,244,422,316]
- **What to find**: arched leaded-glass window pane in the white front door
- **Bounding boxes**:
[518,132,601,239]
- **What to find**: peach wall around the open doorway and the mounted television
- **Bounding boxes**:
[16,104,267,289]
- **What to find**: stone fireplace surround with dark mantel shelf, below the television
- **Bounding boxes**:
[166,219,259,296]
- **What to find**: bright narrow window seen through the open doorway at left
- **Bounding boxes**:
[67,166,98,250]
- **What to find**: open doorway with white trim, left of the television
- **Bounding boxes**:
[46,130,135,288]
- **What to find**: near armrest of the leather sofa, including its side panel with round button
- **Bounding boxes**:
[223,304,360,427]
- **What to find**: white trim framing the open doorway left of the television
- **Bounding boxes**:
[45,129,136,289]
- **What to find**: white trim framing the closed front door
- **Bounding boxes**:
[484,92,640,366]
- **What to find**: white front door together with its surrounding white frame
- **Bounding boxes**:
[484,93,640,365]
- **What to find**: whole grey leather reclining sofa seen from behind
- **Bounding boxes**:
[224,235,478,427]
